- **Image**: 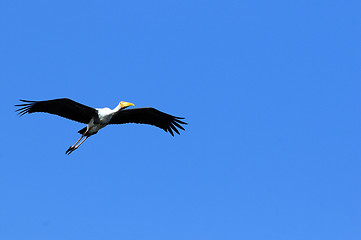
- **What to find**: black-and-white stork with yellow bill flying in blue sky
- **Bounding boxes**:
[15,98,187,155]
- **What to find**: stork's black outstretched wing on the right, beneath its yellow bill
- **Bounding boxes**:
[109,108,187,136]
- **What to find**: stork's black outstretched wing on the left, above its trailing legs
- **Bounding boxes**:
[15,98,97,123]
